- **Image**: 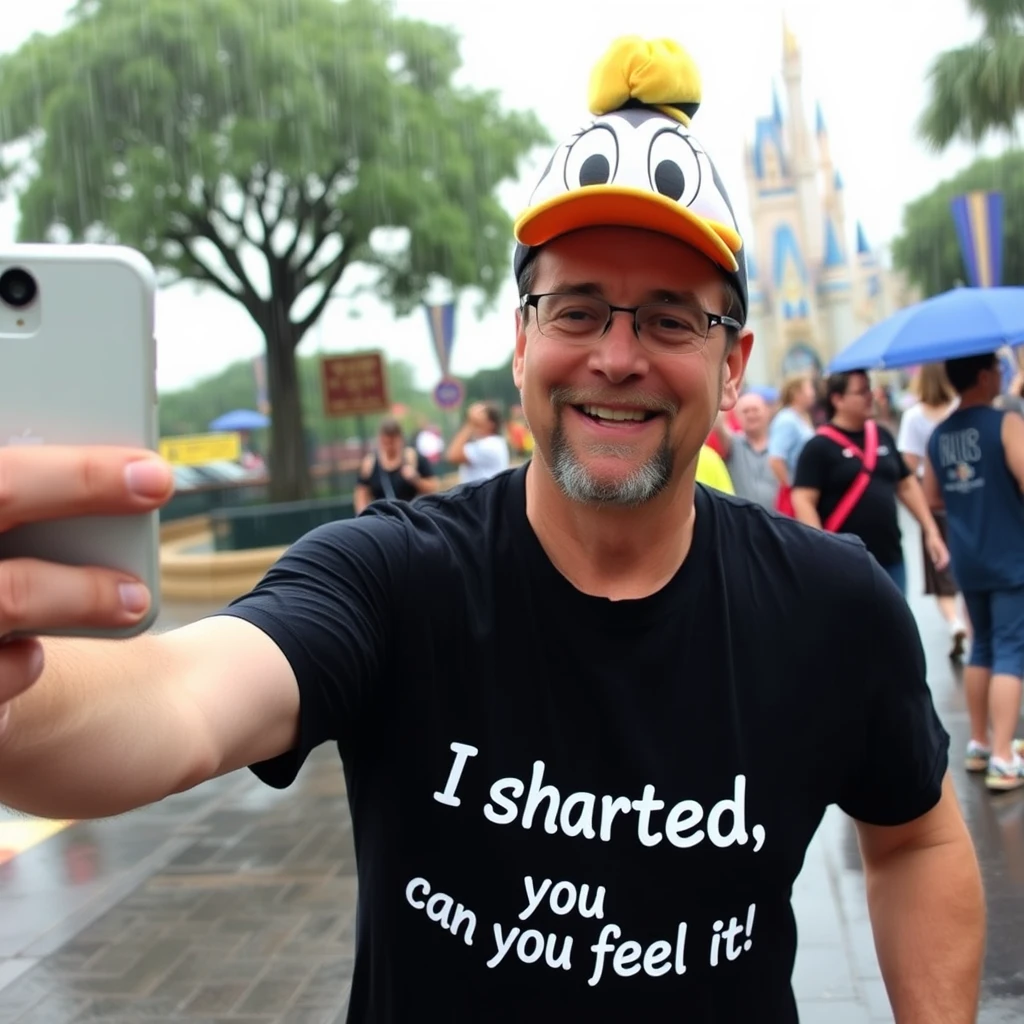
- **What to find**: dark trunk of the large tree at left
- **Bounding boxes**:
[263,310,312,502]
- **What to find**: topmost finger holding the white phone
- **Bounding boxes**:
[0,444,174,530]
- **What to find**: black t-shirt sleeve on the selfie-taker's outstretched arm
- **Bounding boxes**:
[214,508,409,788]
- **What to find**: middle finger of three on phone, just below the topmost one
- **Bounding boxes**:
[0,558,150,634]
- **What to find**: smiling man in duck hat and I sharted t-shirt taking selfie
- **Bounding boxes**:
[0,38,984,1024]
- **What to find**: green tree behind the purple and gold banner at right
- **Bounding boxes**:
[893,152,1024,297]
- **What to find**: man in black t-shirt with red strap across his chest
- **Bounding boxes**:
[793,371,949,594]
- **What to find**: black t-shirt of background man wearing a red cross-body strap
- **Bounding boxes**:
[794,426,910,567]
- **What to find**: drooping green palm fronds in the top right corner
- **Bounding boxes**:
[919,0,1024,150]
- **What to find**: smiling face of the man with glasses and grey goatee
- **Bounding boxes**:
[513,227,753,505]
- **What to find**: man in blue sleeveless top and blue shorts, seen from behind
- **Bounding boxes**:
[925,352,1024,793]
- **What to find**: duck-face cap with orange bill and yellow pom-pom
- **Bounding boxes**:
[513,36,748,319]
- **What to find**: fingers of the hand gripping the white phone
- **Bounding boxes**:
[0,445,174,733]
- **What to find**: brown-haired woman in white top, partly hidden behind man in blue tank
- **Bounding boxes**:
[896,362,968,658]
